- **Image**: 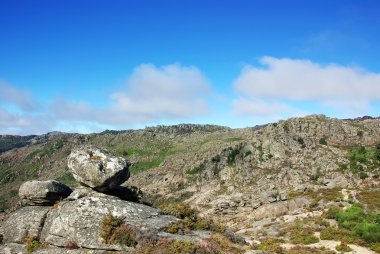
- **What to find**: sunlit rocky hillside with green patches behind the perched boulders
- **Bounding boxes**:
[0,115,380,253]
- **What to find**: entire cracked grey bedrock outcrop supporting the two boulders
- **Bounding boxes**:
[0,187,178,253]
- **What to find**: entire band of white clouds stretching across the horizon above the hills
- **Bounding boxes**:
[0,57,380,134]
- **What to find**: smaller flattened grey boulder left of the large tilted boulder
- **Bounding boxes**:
[18,180,72,206]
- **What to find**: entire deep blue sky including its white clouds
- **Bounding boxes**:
[0,0,380,134]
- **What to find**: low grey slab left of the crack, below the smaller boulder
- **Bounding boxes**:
[0,206,49,243]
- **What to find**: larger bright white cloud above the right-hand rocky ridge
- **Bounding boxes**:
[234,57,380,115]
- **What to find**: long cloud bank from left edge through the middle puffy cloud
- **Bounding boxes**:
[0,64,211,134]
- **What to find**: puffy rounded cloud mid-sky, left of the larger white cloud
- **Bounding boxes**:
[112,64,209,120]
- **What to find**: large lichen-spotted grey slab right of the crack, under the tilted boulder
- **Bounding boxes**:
[41,193,177,250]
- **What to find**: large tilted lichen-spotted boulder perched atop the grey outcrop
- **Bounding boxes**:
[68,146,130,192]
